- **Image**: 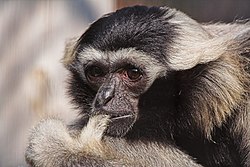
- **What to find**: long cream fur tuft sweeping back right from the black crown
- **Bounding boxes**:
[169,20,250,70]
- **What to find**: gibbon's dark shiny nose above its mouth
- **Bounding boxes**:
[95,85,115,108]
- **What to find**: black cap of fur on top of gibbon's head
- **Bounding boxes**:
[75,6,176,62]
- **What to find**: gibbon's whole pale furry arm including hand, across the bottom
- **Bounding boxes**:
[25,115,201,167]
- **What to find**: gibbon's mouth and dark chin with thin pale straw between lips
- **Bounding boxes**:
[106,114,136,137]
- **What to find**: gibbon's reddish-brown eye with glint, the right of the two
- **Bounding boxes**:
[124,66,142,81]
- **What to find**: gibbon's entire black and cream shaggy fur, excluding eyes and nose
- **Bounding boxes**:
[26,6,250,167]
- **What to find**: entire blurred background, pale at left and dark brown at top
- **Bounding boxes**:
[0,0,250,167]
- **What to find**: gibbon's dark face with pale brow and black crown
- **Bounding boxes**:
[64,6,201,136]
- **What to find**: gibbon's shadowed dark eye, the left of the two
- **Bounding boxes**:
[85,65,105,80]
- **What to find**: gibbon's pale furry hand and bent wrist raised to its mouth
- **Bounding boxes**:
[26,115,112,167]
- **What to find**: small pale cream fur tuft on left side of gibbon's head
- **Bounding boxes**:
[62,36,79,69]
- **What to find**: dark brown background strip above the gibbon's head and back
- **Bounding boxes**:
[116,0,250,22]
